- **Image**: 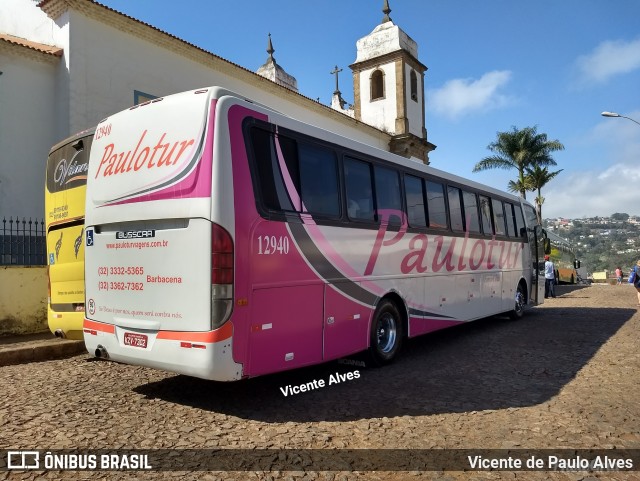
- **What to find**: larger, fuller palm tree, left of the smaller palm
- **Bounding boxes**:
[473,126,564,199]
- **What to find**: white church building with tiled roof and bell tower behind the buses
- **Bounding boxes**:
[0,0,435,219]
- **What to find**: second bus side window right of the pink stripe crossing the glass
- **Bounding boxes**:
[344,157,375,221]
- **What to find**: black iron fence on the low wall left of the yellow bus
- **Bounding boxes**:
[0,217,47,266]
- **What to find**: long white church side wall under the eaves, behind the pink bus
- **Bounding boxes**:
[69,14,388,150]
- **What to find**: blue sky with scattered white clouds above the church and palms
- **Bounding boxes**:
[99,0,640,218]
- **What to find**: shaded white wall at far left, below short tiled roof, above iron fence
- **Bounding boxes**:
[0,51,58,219]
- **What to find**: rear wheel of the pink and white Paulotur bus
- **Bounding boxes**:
[369,299,404,367]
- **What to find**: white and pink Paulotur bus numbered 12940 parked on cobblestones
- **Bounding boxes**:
[83,87,544,381]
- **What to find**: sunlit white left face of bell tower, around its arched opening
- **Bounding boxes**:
[360,63,398,134]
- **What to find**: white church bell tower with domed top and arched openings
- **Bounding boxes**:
[350,0,436,164]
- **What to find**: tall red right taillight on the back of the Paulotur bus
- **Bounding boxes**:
[211,224,233,329]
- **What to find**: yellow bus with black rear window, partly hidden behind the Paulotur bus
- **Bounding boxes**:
[44,129,95,339]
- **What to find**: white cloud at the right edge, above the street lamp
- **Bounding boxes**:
[576,39,640,84]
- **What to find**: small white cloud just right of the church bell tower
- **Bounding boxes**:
[429,70,513,119]
